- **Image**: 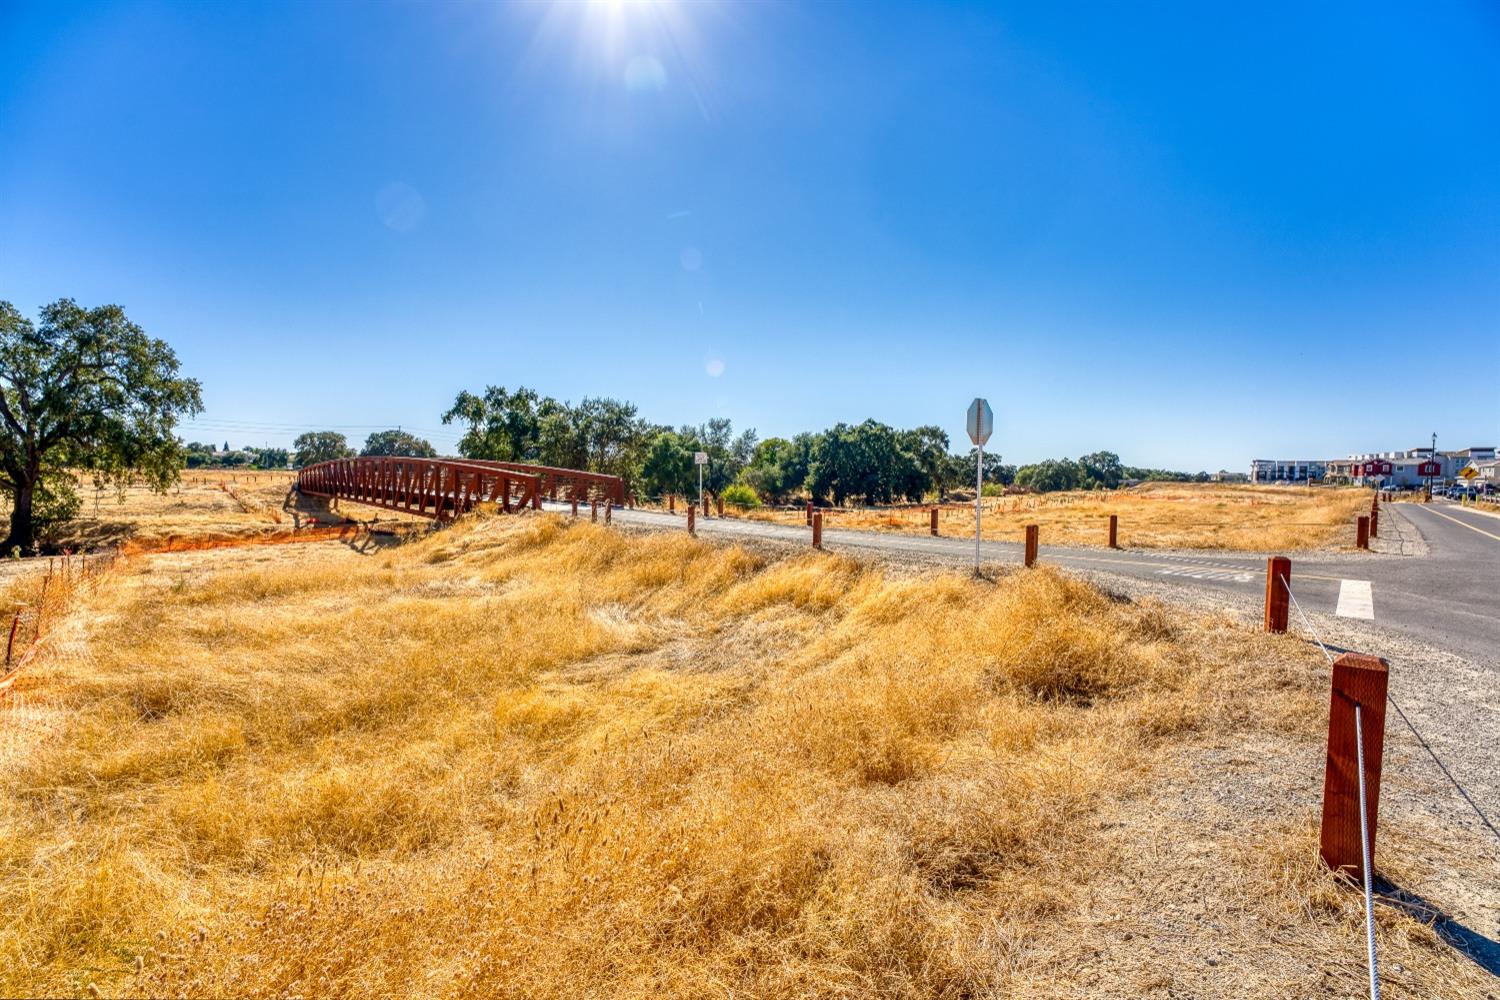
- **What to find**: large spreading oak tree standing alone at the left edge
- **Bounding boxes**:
[0,298,203,552]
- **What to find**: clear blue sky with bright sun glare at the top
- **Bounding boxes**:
[0,0,1500,469]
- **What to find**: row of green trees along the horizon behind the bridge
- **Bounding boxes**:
[258,385,1208,505]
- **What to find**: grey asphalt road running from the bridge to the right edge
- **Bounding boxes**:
[564,502,1500,664]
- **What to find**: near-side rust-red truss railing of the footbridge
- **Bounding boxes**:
[297,456,542,520]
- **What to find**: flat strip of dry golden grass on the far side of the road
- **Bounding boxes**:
[726,483,1371,552]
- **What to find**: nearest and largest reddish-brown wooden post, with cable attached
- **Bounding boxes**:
[1320,652,1391,879]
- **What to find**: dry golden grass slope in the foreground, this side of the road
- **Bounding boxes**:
[0,514,1488,997]
